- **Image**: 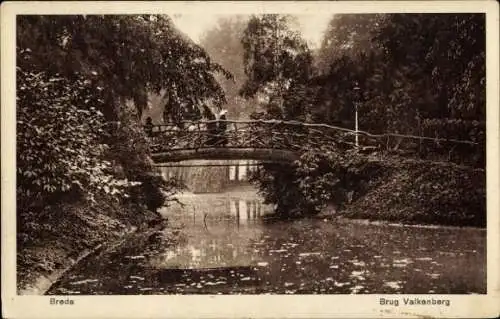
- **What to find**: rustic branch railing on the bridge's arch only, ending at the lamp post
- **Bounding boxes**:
[145,120,364,152]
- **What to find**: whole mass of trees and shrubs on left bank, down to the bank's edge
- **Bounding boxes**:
[16,15,229,288]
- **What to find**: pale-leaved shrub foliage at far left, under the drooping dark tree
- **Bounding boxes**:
[17,68,136,212]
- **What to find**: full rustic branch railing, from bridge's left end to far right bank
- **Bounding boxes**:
[145,120,481,166]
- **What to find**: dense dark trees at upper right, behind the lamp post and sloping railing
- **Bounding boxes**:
[315,14,485,163]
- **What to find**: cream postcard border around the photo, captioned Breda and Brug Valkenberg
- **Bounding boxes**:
[1,1,500,318]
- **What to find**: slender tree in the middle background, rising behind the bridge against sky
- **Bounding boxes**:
[240,14,312,118]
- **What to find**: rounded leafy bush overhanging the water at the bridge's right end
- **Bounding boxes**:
[251,145,382,217]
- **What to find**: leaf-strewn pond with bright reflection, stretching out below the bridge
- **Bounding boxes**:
[48,188,486,295]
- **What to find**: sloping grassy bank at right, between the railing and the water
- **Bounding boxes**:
[337,160,486,227]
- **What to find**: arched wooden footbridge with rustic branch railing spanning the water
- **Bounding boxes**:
[145,120,364,163]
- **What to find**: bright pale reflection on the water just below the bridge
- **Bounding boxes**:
[162,192,265,268]
